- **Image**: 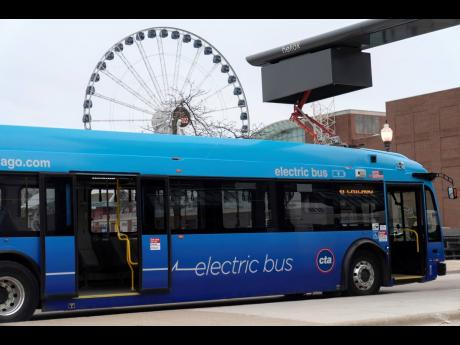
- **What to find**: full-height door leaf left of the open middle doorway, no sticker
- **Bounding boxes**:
[40,175,76,298]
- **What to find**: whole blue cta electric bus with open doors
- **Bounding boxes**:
[0,126,452,322]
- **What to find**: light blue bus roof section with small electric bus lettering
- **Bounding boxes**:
[0,125,426,180]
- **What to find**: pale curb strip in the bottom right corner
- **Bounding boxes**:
[327,309,460,326]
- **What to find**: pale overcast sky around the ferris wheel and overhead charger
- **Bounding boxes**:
[0,19,460,128]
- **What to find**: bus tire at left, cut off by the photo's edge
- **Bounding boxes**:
[0,261,39,323]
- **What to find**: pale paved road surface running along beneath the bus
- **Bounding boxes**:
[11,271,460,326]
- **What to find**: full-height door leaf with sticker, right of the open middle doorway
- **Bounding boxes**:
[141,177,171,290]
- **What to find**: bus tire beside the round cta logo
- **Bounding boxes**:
[347,250,382,296]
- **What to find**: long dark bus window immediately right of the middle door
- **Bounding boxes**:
[169,180,273,233]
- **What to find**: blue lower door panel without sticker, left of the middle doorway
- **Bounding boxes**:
[45,236,76,296]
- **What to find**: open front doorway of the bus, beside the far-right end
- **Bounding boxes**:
[387,185,426,276]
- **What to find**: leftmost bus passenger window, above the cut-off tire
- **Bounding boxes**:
[0,175,40,236]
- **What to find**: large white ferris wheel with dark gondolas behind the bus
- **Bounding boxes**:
[83,27,250,138]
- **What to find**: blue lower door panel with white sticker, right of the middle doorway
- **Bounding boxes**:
[142,235,169,289]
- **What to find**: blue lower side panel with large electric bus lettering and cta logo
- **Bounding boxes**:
[45,231,378,310]
